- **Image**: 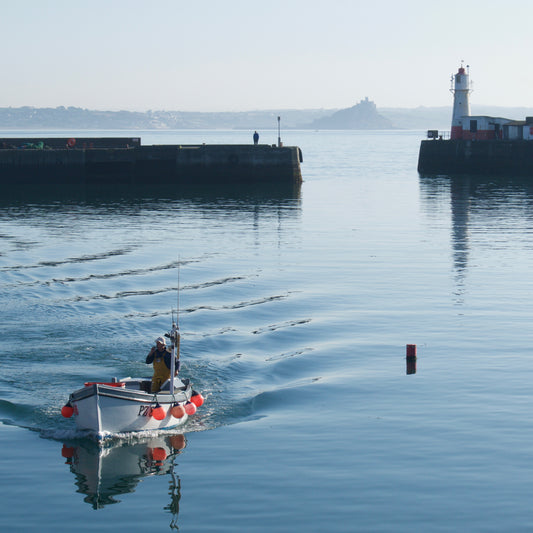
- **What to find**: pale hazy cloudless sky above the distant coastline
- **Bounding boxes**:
[0,0,533,111]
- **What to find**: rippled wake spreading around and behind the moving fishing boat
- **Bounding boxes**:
[0,246,316,442]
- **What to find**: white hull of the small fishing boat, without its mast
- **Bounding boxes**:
[69,379,192,437]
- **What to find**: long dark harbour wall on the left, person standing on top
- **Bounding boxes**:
[0,138,303,185]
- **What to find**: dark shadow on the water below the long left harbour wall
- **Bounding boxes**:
[0,182,301,208]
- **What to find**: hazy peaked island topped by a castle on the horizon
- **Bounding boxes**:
[308,98,393,130]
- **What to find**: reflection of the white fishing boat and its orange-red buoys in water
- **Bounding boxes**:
[61,434,186,522]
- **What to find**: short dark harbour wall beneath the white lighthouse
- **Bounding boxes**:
[418,139,533,176]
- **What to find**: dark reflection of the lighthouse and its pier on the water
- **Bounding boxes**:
[419,174,533,301]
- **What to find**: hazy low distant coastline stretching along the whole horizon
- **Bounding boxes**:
[0,104,533,131]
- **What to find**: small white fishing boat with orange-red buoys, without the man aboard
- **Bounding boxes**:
[61,320,204,439]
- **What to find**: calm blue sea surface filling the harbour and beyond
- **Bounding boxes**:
[0,131,533,533]
